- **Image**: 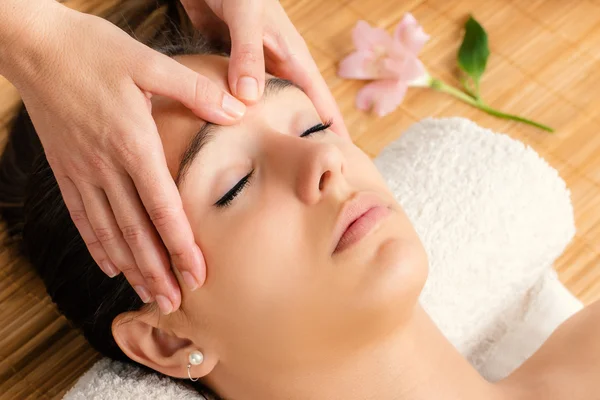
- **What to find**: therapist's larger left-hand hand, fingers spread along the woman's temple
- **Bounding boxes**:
[7,1,245,313]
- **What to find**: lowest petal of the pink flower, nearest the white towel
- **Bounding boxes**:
[356,80,408,117]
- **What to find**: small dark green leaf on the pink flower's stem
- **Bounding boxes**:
[458,15,490,96]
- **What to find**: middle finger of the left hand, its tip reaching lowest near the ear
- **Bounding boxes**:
[105,176,181,315]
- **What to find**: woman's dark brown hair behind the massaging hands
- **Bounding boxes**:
[0,0,227,399]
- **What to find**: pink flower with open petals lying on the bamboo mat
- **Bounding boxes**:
[338,13,429,116]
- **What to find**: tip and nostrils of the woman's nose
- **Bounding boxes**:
[296,142,344,204]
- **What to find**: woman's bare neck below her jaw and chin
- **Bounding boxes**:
[223,306,506,400]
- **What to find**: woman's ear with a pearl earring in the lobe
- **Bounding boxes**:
[112,310,219,379]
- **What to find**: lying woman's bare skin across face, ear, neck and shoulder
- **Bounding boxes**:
[112,55,600,400]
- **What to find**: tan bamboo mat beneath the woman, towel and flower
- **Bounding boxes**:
[0,0,600,400]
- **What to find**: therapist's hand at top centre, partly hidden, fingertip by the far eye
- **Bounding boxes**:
[181,0,348,136]
